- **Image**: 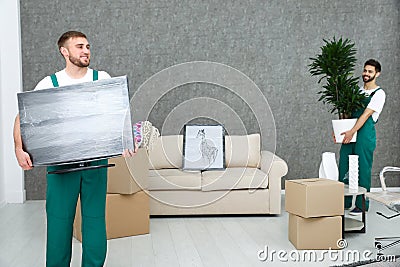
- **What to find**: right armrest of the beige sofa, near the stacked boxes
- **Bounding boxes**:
[260,151,288,214]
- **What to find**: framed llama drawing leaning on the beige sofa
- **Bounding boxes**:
[183,125,225,170]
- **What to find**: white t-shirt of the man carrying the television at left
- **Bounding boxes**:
[35,68,111,90]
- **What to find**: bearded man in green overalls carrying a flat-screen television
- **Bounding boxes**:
[14,31,136,267]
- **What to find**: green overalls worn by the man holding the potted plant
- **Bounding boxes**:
[339,88,381,213]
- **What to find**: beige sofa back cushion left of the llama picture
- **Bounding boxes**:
[149,135,183,170]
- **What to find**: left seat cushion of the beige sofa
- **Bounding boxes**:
[148,169,201,190]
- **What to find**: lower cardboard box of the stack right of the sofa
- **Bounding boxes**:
[289,214,342,250]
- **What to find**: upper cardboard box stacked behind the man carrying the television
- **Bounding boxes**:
[107,148,149,194]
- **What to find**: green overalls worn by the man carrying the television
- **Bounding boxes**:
[46,71,107,267]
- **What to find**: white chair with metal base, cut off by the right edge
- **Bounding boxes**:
[367,166,400,255]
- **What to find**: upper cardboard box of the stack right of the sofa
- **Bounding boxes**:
[285,178,344,218]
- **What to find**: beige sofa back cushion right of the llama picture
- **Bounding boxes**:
[225,134,261,168]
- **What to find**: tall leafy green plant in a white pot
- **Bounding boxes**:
[308,37,366,143]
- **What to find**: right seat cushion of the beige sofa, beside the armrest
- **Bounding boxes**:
[201,168,268,191]
